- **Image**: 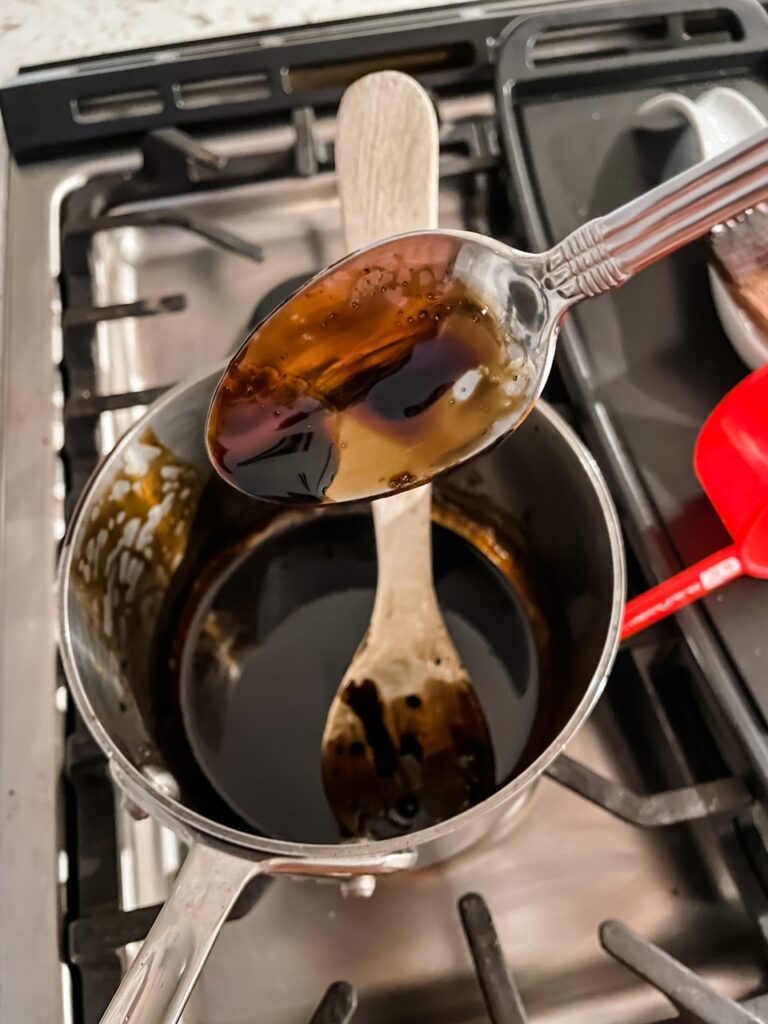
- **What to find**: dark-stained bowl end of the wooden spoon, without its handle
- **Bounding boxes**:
[323,626,496,839]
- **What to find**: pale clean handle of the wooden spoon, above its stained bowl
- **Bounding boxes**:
[336,71,440,622]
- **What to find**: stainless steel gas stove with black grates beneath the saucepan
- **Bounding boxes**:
[0,0,768,1024]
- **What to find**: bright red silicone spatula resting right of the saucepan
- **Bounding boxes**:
[622,367,768,640]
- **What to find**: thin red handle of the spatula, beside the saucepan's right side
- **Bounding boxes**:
[622,544,744,640]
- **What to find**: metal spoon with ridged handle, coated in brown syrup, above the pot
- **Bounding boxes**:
[209,122,768,502]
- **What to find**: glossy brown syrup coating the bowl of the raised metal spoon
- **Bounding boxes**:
[208,233,520,503]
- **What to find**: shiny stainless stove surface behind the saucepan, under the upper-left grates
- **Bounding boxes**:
[92,174,463,451]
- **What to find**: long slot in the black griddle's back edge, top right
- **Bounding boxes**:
[529,10,743,68]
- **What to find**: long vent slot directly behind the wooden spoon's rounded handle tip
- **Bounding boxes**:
[283,43,476,92]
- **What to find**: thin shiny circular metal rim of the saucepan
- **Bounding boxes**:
[57,365,626,861]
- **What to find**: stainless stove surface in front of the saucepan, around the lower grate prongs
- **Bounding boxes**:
[193,720,761,1024]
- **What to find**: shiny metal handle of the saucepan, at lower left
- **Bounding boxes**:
[101,844,262,1024]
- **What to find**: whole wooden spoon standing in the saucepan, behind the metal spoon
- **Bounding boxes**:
[323,72,496,838]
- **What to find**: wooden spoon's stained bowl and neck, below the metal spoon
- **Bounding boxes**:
[323,479,496,839]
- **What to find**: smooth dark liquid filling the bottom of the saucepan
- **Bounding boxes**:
[174,513,539,843]
